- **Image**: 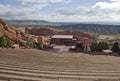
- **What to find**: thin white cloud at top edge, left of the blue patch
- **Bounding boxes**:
[19,0,71,10]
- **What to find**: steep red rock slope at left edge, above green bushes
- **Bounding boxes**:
[0,18,32,42]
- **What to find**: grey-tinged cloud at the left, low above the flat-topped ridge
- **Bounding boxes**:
[0,5,41,20]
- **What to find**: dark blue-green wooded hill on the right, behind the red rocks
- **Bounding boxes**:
[52,24,120,34]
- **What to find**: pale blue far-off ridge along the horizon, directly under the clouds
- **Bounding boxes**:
[5,20,120,25]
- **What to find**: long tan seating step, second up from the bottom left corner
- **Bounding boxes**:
[0,69,120,77]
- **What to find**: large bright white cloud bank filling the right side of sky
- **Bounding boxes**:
[56,0,120,21]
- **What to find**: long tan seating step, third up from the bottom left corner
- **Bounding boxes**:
[0,66,120,74]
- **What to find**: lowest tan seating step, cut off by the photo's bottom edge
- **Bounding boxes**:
[0,74,94,81]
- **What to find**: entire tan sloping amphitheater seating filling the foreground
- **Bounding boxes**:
[0,49,120,81]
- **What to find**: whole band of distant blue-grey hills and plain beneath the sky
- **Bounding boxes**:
[7,20,120,34]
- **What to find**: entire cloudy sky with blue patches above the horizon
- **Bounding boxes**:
[0,0,120,22]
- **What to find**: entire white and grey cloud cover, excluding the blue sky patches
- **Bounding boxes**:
[0,0,120,22]
